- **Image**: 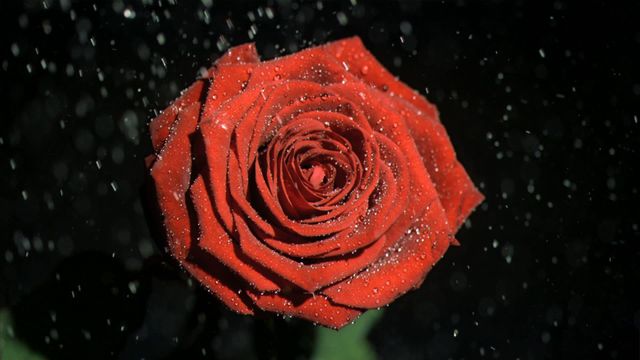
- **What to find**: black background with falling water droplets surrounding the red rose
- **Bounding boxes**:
[0,0,640,359]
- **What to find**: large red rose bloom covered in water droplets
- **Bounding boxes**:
[148,38,482,328]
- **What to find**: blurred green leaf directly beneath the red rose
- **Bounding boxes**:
[311,310,383,360]
